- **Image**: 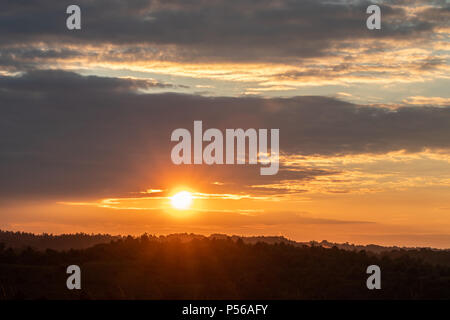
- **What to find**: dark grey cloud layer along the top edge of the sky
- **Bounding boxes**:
[0,0,449,61]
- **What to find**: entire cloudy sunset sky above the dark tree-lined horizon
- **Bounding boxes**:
[0,0,450,248]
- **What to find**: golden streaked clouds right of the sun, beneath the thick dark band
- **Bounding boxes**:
[252,150,450,195]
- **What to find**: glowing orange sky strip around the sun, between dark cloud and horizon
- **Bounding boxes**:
[1,149,450,248]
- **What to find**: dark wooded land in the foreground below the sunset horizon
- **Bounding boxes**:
[0,235,450,299]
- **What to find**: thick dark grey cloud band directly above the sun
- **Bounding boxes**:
[0,71,450,197]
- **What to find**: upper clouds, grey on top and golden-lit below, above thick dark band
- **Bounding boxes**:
[0,0,450,96]
